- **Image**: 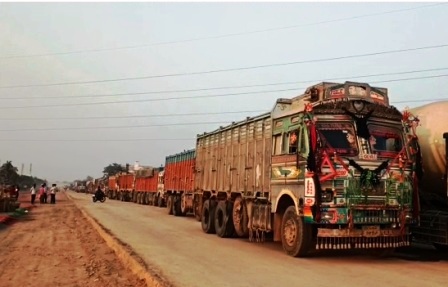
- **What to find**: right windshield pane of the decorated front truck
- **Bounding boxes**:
[368,124,403,158]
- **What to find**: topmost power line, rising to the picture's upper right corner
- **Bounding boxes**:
[0,3,440,60]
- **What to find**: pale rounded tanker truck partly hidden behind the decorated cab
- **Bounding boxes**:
[411,101,448,251]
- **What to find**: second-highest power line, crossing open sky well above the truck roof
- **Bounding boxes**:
[0,44,448,89]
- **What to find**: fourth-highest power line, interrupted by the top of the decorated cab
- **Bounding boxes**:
[0,74,448,110]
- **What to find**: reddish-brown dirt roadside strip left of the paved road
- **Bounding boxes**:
[0,192,147,287]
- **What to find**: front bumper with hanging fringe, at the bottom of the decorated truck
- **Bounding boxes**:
[316,228,411,249]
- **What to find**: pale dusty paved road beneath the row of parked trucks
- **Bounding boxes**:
[69,192,448,287]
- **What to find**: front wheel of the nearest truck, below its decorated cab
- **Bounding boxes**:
[281,206,312,257]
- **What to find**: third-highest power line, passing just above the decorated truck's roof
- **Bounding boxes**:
[0,67,448,100]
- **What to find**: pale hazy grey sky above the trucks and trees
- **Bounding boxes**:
[0,2,448,181]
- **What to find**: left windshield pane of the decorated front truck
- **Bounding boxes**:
[316,121,358,156]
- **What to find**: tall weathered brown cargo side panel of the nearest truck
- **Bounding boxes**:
[195,114,272,196]
